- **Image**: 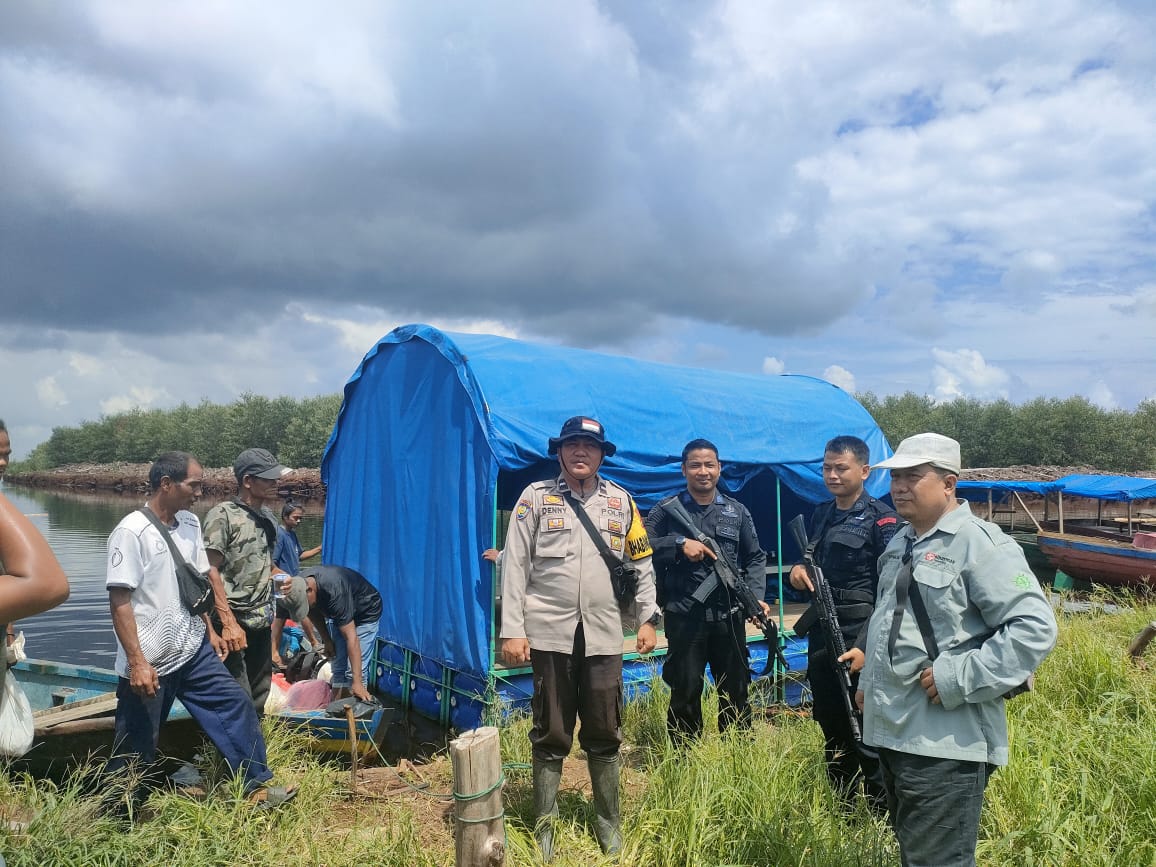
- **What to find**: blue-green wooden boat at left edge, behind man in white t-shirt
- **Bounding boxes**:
[8,659,203,776]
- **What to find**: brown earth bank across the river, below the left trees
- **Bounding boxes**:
[6,464,325,499]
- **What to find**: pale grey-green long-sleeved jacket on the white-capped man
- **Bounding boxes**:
[859,499,1057,765]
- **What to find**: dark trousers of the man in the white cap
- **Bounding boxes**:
[879,749,995,867]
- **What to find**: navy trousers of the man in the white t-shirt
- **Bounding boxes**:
[109,639,273,788]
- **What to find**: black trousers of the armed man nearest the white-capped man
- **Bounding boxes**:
[807,630,887,810]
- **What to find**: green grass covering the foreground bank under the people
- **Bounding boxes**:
[0,603,1156,867]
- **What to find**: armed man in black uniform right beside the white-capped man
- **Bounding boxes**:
[791,436,904,812]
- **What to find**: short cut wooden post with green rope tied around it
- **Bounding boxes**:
[450,726,505,867]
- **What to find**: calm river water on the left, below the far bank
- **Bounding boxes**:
[2,484,324,668]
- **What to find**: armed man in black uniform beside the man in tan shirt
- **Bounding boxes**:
[646,439,770,742]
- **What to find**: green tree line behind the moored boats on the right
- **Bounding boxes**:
[858,392,1156,473]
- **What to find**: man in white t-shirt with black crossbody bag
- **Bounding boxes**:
[105,452,296,805]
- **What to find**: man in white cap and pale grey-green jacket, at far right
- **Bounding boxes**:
[857,434,1055,867]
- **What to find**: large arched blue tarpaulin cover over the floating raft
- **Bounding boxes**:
[321,325,891,674]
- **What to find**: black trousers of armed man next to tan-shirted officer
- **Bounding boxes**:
[662,614,750,740]
